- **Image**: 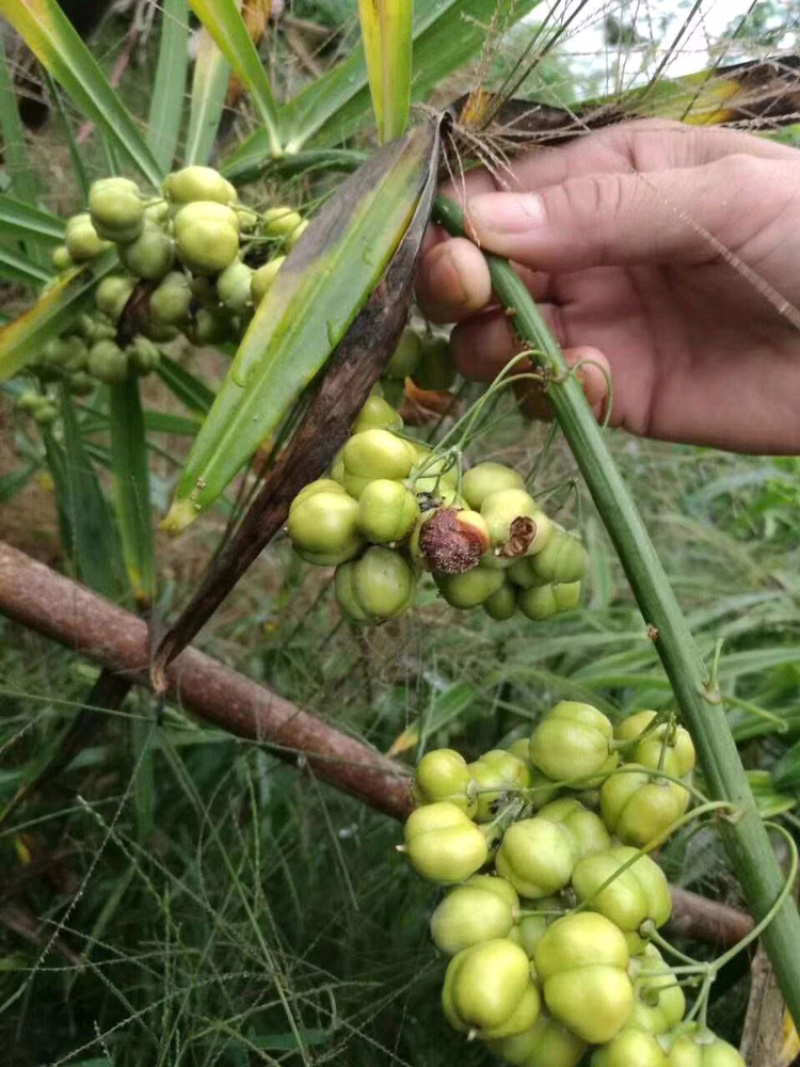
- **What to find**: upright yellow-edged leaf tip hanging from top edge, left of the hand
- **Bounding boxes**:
[358,0,414,144]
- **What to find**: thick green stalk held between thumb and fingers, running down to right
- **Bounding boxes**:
[433,197,800,1024]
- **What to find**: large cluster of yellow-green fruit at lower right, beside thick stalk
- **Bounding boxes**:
[401,701,743,1067]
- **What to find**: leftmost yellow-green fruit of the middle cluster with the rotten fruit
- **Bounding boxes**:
[289,491,363,567]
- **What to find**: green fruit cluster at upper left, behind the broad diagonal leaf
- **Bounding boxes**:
[23,166,307,401]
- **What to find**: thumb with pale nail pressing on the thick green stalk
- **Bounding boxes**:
[466,156,768,272]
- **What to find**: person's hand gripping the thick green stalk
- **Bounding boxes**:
[417,120,800,455]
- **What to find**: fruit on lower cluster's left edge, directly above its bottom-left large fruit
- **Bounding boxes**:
[431,875,519,956]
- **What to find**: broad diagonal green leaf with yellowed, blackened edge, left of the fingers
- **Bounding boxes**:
[164,124,438,532]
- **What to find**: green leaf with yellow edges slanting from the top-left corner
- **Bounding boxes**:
[0,0,163,187]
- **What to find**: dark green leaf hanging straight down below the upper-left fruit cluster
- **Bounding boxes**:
[109,377,155,607]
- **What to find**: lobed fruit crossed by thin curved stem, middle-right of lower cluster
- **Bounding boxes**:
[572,847,672,934]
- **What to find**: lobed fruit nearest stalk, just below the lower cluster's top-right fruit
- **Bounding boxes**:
[601,763,689,846]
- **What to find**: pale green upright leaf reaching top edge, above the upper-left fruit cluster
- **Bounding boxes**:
[147,0,189,171]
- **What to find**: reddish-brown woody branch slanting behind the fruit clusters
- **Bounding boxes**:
[0,541,753,947]
